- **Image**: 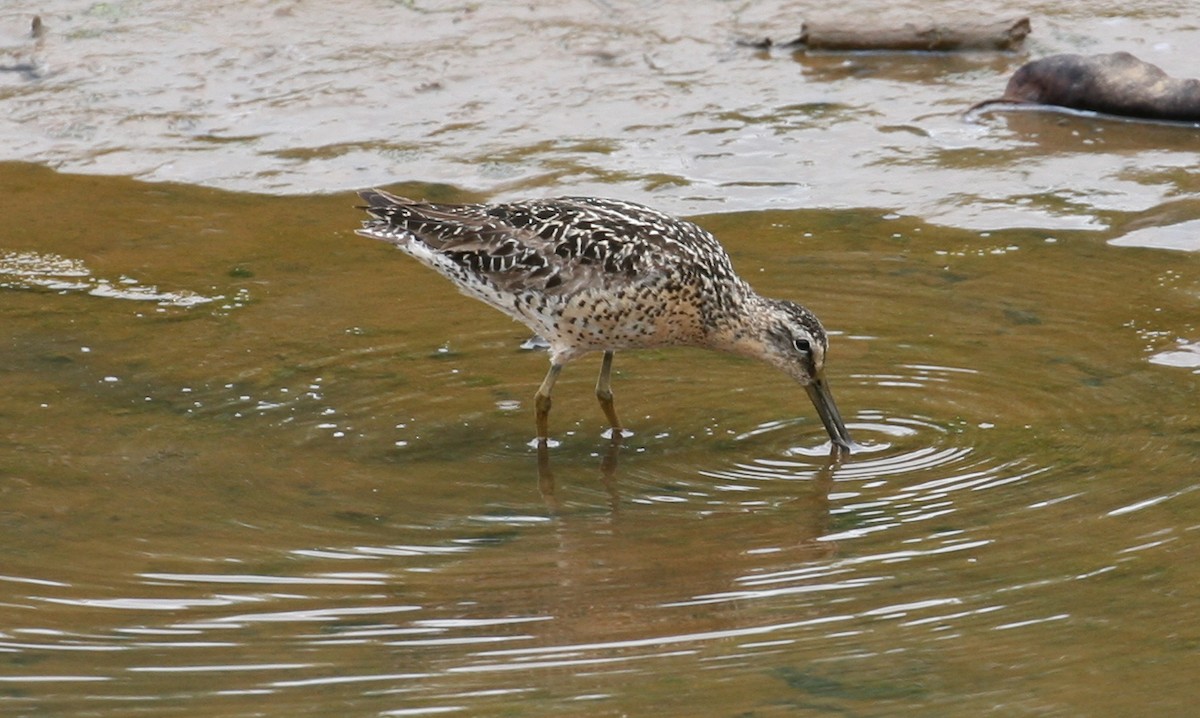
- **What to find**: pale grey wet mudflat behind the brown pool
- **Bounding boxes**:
[0,0,1200,229]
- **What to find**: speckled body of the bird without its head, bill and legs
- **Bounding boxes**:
[359,190,749,359]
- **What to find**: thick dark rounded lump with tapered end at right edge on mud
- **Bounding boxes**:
[968,53,1200,122]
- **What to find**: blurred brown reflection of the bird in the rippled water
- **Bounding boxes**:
[508,437,844,653]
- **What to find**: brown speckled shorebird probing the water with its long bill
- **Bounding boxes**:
[358,190,854,451]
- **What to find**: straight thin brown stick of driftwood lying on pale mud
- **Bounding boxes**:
[796,18,1031,53]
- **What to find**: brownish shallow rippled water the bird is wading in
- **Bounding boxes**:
[0,164,1200,716]
